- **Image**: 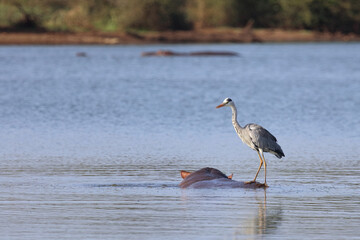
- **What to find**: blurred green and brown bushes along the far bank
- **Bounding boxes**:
[0,0,360,34]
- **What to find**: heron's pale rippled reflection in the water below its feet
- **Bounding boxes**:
[234,190,282,239]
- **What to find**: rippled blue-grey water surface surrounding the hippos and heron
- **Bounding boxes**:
[0,43,360,239]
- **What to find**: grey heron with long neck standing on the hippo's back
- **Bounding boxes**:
[216,98,285,184]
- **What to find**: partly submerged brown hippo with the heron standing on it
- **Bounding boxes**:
[180,167,266,189]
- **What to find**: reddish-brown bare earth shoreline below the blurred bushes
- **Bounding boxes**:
[0,28,360,45]
